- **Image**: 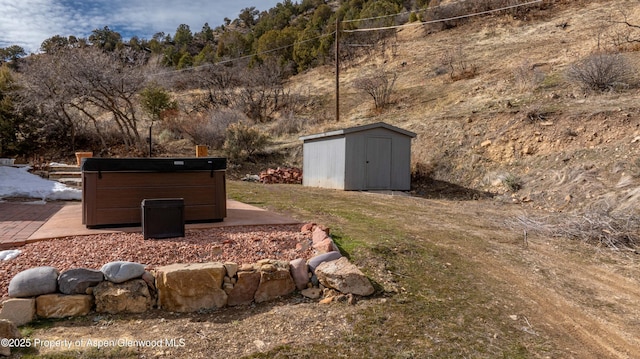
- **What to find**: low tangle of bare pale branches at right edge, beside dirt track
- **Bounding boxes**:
[506,210,640,249]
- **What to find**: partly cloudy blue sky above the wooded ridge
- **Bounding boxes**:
[0,0,282,53]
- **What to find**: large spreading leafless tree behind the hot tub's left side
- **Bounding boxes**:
[23,48,144,150]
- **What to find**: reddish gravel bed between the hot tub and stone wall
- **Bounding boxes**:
[0,225,313,300]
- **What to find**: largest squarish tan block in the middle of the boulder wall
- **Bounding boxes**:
[156,262,227,312]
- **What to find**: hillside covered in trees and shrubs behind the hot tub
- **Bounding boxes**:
[0,0,551,159]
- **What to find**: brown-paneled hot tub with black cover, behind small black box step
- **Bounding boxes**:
[82,157,227,228]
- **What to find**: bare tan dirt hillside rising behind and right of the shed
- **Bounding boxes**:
[292,0,640,217]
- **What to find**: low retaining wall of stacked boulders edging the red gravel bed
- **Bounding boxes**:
[0,223,375,355]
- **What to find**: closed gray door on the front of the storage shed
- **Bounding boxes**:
[365,137,391,189]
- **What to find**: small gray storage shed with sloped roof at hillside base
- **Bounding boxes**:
[300,122,416,191]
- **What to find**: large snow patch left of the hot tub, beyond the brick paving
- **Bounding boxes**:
[0,166,82,203]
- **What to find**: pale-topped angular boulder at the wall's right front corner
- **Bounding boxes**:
[315,257,375,296]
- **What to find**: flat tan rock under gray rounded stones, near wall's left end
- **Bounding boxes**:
[36,293,93,318]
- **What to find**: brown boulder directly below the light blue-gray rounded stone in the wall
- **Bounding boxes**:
[93,279,154,314]
